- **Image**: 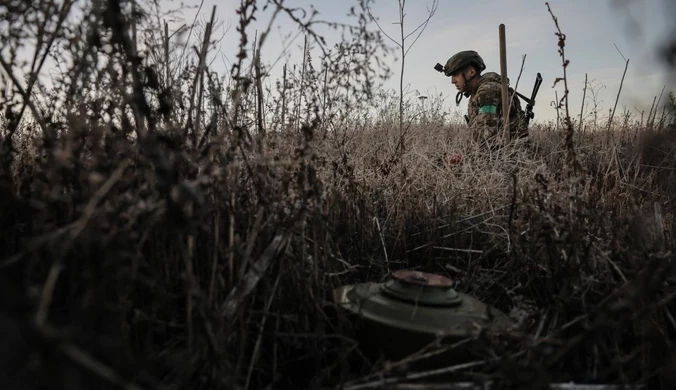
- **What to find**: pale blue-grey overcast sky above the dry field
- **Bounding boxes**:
[163,0,676,120]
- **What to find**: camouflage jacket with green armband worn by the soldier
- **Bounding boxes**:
[467,72,528,143]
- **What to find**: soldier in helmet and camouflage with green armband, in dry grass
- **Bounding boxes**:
[443,50,528,147]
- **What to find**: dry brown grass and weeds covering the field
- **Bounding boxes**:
[0,0,676,389]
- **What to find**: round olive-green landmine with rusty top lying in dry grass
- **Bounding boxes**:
[334,270,643,390]
